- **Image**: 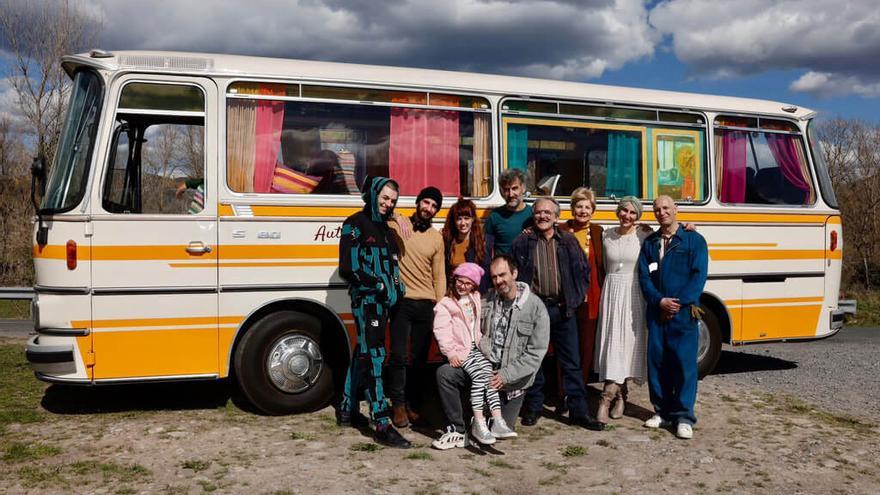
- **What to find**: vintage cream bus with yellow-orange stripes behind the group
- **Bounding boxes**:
[26,50,843,414]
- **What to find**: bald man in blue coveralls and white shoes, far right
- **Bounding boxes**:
[639,196,709,439]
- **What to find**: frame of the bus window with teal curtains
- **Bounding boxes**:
[498,95,715,206]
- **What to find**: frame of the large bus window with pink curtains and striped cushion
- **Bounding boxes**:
[215,78,499,205]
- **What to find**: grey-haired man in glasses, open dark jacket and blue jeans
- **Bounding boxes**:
[511,198,604,430]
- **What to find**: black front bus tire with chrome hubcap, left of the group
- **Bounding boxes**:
[234,311,333,415]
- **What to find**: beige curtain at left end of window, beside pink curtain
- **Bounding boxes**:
[226,99,257,192]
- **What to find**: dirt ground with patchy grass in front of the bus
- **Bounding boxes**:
[0,340,880,495]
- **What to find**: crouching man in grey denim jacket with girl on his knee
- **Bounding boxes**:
[432,255,550,449]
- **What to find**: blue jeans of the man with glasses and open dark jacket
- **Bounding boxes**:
[525,305,587,418]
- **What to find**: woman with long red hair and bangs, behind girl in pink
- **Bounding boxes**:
[442,198,488,287]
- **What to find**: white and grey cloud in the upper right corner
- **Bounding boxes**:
[650,0,880,96]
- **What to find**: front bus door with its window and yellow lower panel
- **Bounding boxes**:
[91,75,218,380]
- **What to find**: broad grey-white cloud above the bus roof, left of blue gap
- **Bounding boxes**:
[79,0,659,79]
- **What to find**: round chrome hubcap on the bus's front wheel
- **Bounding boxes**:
[266,335,324,393]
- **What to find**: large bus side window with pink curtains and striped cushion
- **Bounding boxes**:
[226,83,492,197]
